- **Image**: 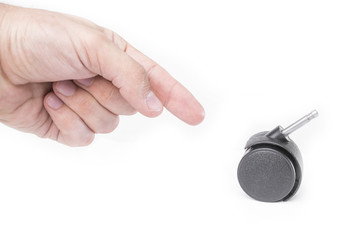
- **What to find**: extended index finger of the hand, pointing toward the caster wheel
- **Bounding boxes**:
[105,32,205,125]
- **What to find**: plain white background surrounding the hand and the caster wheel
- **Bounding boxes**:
[0,0,359,240]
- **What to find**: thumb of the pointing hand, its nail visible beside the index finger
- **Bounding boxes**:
[82,37,163,117]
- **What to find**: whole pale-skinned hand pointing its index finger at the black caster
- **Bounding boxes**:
[0,4,204,146]
